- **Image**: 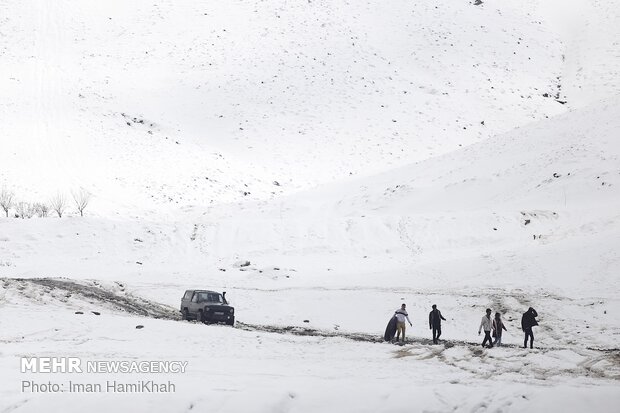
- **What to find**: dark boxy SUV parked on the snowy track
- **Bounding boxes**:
[181,290,235,326]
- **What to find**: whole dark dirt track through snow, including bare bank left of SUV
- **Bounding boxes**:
[0,278,620,380]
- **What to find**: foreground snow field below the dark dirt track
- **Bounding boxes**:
[0,290,619,412]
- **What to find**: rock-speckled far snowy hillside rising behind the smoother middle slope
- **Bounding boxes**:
[0,0,618,213]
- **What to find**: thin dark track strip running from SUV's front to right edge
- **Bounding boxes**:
[235,321,620,357]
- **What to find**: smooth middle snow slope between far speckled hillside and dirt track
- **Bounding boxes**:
[0,97,620,347]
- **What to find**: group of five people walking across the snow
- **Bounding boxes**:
[385,304,538,348]
